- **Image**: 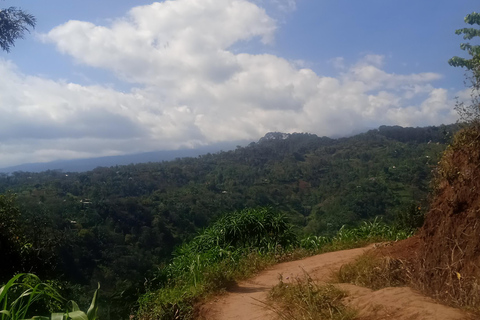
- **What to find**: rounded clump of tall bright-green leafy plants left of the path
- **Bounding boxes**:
[165,208,296,284]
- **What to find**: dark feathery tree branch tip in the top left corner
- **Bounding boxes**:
[0,7,36,52]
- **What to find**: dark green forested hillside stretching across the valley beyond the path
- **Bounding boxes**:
[0,125,457,319]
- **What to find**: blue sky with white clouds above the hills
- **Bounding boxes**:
[0,0,480,167]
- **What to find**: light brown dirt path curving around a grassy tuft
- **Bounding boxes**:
[200,247,469,320]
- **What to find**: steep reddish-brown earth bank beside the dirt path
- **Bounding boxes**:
[414,128,480,308]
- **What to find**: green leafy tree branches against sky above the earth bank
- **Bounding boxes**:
[448,12,480,124]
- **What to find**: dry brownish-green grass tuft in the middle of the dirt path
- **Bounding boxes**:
[269,273,356,320]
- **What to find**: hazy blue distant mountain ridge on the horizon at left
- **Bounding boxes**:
[0,141,250,173]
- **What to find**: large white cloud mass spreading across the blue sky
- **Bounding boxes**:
[0,0,455,166]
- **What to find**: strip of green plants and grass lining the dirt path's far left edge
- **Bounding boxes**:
[138,208,411,320]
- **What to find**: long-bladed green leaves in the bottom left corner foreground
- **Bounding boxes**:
[0,274,100,320]
